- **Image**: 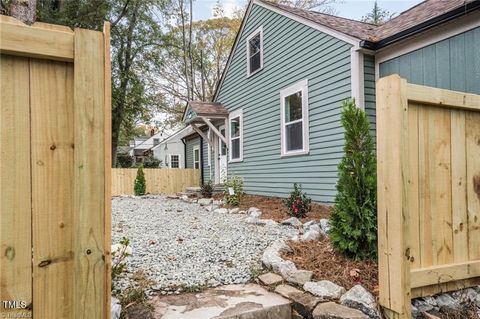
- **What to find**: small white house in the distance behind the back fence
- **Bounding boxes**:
[151,126,193,168]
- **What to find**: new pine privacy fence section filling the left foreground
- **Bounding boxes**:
[0,16,111,319]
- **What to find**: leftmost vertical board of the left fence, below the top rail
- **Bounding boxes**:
[0,54,32,316]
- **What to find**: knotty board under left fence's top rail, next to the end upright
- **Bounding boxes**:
[30,59,74,319]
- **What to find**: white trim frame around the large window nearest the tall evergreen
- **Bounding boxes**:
[280,79,310,157]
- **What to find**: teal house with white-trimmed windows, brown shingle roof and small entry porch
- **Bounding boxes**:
[184,0,480,202]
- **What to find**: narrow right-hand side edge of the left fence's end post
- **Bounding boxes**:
[103,22,112,319]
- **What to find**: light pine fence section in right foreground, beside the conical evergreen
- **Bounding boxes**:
[377,75,480,318]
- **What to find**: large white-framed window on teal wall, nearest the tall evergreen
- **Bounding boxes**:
[280,80,310,156]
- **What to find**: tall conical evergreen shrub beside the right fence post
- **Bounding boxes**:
[329,99,376,259]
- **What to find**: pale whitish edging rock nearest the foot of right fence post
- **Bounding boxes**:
[340,285,381,319]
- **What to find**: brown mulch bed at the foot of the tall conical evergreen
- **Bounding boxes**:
[282,237,378,296]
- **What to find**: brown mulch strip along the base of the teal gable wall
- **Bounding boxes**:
[217,195,332,223]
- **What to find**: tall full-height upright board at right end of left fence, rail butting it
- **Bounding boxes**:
[74,29,108,319]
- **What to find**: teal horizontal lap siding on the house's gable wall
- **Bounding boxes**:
[215,5,351,202]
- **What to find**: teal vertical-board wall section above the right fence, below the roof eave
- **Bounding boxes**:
[380,27,480,94]
